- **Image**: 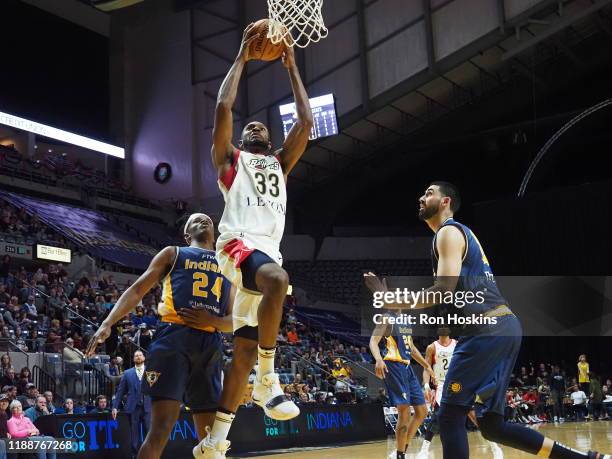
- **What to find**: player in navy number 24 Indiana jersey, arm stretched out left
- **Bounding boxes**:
[87,214,233,459]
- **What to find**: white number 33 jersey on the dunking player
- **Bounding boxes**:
[217,150,287,264]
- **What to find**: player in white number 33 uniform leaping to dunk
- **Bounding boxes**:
[193,24,313,458]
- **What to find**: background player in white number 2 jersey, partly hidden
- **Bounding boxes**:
[416,328,504,459]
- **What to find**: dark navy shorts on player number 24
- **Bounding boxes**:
[142,324,223,412]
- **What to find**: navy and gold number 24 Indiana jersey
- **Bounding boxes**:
[158,247,232,332]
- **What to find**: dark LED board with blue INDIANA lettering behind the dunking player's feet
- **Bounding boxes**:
[162,403,386,459]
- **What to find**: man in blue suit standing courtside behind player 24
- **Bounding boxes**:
[111,351,151,456]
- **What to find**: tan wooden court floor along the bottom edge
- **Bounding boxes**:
[243,421,612,459]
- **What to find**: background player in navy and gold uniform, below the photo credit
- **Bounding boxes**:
[370,312,433,459]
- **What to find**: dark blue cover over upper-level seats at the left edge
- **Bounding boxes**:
[0,191,157,269]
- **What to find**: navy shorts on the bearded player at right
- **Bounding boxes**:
[442,315,523,417]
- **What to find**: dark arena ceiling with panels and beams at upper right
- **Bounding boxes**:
[185,0,612,203]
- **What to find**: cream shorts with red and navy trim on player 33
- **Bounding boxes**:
[217,239,282,332]
